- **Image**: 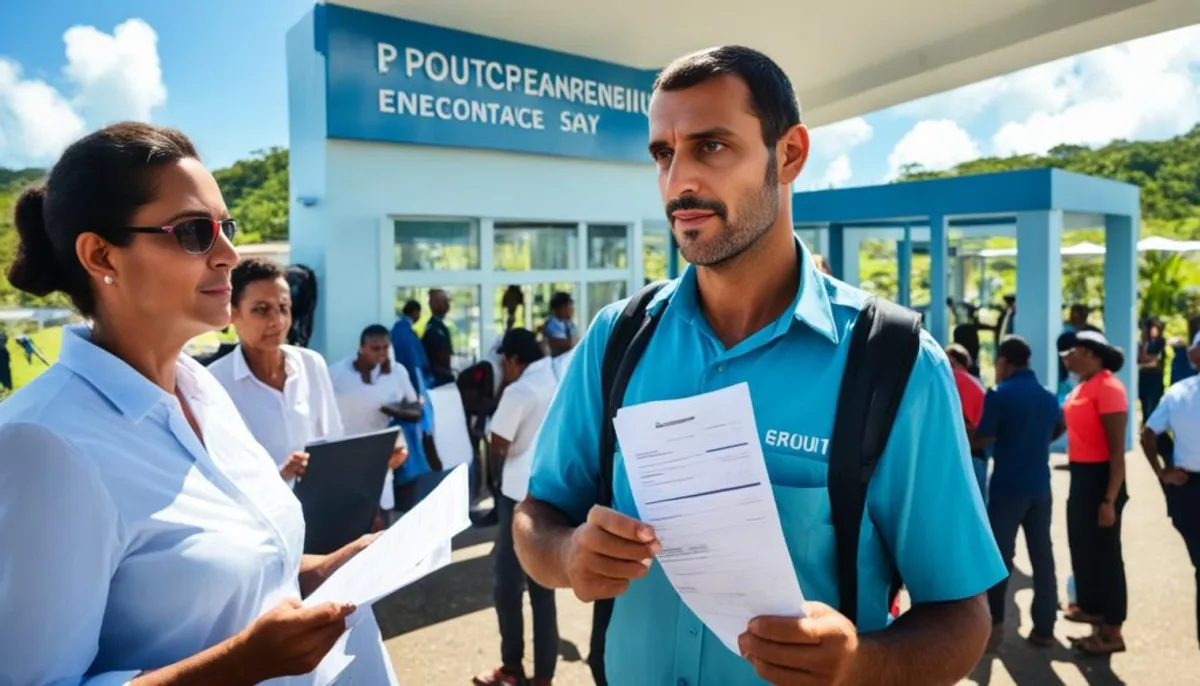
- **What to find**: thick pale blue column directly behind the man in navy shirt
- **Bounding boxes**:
[1013,210,1062,392]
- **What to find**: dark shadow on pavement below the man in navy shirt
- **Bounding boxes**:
[968,568,1124,686]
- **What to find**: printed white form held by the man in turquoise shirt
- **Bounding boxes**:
[614,384,804,652]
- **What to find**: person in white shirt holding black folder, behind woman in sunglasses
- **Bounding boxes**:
[209,258,343,485]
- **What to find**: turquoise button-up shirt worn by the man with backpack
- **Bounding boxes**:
[529,242,1007,686]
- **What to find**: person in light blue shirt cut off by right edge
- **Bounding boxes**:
[1141,332,1200,642]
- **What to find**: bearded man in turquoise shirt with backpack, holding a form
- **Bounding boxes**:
[514,47,1006,686]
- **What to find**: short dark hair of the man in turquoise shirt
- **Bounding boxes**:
[654,46,800,148]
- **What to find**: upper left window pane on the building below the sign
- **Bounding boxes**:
[395,219,479,271]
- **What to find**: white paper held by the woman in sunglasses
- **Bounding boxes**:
[304,465,470,608]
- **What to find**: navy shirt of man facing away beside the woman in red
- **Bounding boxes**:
[976,369,1062,500]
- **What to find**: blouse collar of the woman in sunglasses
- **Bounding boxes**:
[59,324,172,421]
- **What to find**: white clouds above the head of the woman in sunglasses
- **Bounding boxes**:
[0,19,167,167]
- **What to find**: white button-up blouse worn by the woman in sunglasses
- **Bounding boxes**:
[0,326,395,686]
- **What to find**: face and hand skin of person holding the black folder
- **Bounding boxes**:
[232,277,308,480]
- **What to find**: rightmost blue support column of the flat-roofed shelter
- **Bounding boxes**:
[1104,215,1141,450]
